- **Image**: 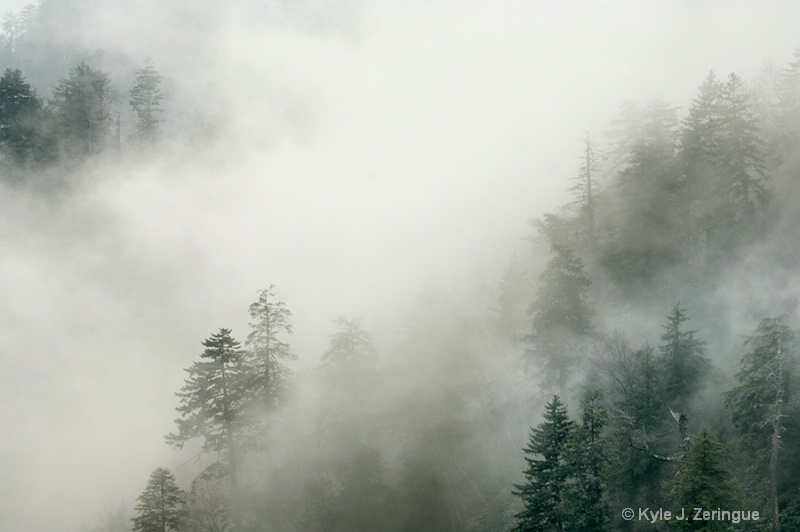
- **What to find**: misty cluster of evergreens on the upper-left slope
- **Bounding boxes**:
[0,2,164,179]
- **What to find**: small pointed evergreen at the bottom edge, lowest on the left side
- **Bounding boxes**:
[132,467,185,532]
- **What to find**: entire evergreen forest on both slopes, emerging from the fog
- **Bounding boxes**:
[0,0,800,532]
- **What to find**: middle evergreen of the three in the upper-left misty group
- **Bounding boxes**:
[54,63,114,158]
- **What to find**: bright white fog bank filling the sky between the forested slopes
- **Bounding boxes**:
[0,0,800,531]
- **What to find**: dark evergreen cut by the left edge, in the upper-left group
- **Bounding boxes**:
[0,68,42,163]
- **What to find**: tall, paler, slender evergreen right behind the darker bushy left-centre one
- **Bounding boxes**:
[246,285,295,411]
